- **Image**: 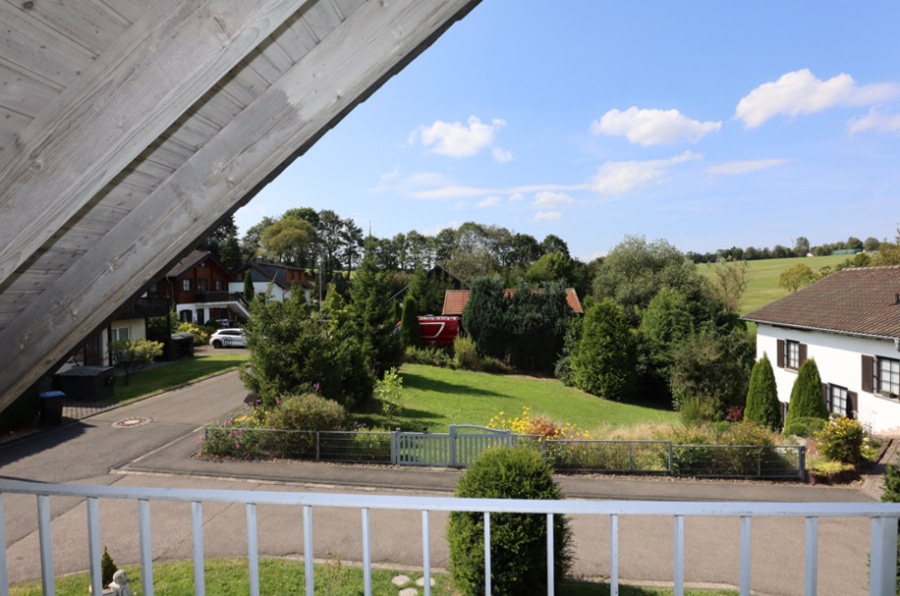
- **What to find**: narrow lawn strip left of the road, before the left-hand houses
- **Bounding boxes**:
[105,350,249,403]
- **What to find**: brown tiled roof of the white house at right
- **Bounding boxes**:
[743,266,900,338]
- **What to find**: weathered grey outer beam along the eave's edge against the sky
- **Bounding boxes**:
[0,0,478,408]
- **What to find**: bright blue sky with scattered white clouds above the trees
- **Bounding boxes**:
[235,0,900,260]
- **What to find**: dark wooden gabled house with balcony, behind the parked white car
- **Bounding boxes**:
[147,250,250,325]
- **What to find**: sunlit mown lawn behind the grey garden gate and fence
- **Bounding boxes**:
[394,364,676,432]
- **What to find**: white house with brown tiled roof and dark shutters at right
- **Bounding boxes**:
[743,266,900,433]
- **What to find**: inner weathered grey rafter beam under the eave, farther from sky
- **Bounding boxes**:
[0,0,316,283]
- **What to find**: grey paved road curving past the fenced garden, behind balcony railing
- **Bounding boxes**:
[0,373,873,595]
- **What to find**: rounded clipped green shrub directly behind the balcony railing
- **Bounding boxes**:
[447,448,572,595]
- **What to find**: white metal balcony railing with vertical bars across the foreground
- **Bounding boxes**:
[0,481,900,596]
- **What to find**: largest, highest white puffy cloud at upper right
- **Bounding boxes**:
[735,68,900,128]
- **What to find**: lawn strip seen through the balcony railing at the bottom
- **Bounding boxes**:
[9,559,737,596]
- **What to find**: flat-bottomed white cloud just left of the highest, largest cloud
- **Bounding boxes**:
[591,106,722,147]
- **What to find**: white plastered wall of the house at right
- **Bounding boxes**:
[756,323,900,433]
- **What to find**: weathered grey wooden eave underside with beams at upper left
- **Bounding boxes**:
[0,0,486,410]
